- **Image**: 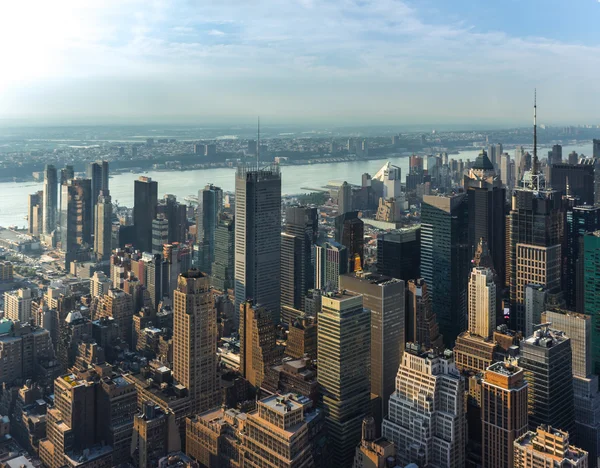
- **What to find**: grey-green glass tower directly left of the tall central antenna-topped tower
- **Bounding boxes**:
[211,219,237,292]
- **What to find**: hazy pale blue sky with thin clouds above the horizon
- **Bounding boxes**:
[0,0,600,124]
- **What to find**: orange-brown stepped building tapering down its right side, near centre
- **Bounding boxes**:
[239,301,282,388]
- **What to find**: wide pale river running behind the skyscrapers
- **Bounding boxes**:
[0,142,592,227]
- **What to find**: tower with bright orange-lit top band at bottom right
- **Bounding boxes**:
[481,362,527,468]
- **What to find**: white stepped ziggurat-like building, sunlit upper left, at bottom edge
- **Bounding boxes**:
[382,348,467,468]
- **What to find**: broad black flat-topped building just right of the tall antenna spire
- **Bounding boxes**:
[549,164,594,205]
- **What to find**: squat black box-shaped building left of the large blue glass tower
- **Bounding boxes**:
[377,226,421,282]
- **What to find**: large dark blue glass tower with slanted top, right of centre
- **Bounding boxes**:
[421,193,472,348]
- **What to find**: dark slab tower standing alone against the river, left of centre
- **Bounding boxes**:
[133,176,158,252]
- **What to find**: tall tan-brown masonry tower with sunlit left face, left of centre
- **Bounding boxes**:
[173,270,220,414]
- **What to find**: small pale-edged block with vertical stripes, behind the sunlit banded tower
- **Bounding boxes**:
[313,241,348,291]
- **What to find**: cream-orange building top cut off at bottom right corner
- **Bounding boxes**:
[512,425,590,468]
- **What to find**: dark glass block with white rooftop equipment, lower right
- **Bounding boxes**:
[519,324,575,433]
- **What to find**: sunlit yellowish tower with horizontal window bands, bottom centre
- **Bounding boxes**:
[317,293,371,466]
